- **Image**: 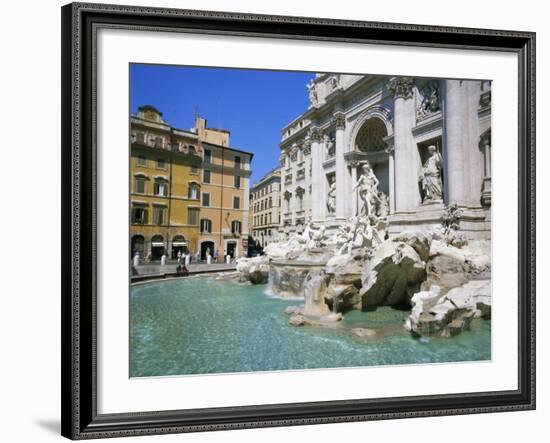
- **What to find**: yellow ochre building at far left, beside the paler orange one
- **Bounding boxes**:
[130,106,202,260]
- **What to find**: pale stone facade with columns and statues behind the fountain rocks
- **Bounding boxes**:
[280,74,491,238]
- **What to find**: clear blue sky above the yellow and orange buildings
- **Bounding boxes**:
[130,64,314,183]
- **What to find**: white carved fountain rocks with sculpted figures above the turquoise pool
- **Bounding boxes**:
[237,198,491,338]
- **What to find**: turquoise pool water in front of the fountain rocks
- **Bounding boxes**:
[130,278,491,377]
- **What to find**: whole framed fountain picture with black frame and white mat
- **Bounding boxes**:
[62,3,535,439]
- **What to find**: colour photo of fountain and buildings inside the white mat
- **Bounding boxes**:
[130,63,492,378]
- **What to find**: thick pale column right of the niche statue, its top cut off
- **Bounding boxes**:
[444,80,482,206]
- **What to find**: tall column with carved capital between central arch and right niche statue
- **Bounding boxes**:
[389,77,420,212]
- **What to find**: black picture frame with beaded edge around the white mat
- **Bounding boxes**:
[61,3,535,439]
